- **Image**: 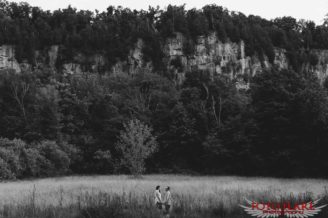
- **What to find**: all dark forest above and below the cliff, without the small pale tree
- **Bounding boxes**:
[0,1,328,179]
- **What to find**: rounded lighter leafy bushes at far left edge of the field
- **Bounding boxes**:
[0,138,78,179]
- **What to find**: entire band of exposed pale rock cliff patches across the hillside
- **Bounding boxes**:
[0,33,328,88]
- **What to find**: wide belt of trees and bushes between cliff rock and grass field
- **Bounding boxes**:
[0,69,328,178]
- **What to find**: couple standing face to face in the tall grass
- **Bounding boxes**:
[154,185,172,217]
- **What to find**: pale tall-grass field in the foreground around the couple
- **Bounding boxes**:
[0,175,328,218]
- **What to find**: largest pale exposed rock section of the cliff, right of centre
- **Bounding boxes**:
[164,33,288,85]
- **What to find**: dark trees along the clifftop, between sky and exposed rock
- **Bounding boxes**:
[0,0,328,71]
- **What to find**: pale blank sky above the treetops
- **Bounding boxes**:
[10,0,328,24]
